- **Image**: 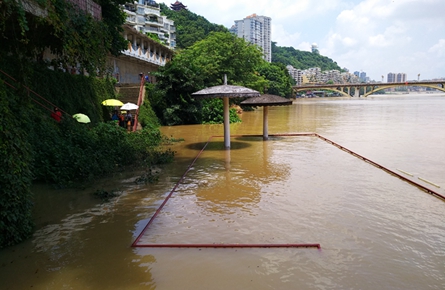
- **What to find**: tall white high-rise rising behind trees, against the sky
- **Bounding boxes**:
[230,14,272,62]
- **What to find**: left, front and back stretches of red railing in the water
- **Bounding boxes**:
[131,133,321,249]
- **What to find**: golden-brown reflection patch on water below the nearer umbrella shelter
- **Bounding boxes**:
[190,137,289,214]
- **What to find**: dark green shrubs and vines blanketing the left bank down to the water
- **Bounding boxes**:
[0,58,173,248]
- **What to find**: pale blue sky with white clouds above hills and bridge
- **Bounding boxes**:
[158,0,445,82]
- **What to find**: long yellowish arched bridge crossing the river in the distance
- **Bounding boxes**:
[292,80,445,97]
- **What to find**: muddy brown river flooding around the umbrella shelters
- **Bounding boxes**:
[0,94,445,290]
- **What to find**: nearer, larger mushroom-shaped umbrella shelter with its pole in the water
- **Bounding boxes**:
[192,75,261,149]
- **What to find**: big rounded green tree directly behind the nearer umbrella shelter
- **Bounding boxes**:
[150,32,267,125]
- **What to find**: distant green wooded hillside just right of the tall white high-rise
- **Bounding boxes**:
[272,42,341,71]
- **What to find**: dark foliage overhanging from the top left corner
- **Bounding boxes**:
[0,0,127,75]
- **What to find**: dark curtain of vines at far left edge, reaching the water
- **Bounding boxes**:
[0,82,33,248]
